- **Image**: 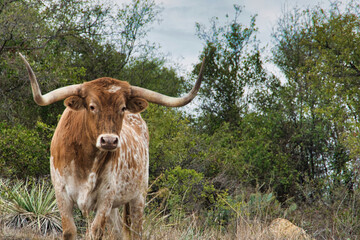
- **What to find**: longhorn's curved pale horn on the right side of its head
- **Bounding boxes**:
[131,58,205,107]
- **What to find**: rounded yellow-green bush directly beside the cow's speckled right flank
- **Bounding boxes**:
[143,104,197,177]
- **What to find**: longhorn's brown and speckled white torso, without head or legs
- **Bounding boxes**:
[50,110,149,212]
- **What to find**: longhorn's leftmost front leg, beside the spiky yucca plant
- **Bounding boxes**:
[55,191,76,240]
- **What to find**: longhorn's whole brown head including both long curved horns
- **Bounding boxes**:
[20,54,205,151]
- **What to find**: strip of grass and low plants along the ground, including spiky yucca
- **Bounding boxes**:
[0,179,360,240]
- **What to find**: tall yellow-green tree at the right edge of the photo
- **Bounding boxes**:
[274,1,360,197]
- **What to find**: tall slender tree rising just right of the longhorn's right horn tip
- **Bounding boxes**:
[194,5,263,132]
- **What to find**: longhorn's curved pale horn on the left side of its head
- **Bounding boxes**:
[19,53,82,106]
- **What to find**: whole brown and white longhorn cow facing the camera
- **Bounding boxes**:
[20,54,205,239]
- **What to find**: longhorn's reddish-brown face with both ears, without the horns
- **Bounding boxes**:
[65,78,148,151]
